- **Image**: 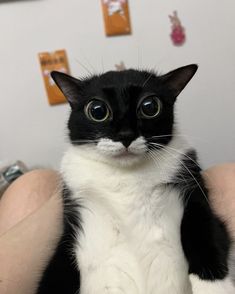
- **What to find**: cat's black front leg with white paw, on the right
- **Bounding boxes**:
[181,185,235,294]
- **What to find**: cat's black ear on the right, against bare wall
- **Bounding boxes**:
[161,64,198,100]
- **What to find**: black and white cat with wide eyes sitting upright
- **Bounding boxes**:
[38,65,235,294]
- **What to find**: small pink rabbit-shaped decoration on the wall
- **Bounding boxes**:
[169,11,186,46]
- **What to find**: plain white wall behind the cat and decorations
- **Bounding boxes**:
[0,0,235,167]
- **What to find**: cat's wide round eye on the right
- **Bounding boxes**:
[137,96,162,119]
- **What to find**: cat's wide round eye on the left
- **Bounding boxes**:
[85,99,111,122]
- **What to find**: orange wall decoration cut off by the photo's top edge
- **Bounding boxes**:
[101,0,131,36]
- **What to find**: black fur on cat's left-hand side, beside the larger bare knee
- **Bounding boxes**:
[37,188,81,294]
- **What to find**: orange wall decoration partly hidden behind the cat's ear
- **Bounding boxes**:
[39,50,69,105]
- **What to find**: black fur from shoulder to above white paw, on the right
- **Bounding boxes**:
[172,150,231,280]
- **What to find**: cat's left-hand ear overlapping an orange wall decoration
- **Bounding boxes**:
[51,71,81,108]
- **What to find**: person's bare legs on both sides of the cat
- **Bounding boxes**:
[0,164,235,294]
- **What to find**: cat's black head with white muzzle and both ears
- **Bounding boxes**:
[52,64,197,165]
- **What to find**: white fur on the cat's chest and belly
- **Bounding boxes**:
[62,137,235,294]
